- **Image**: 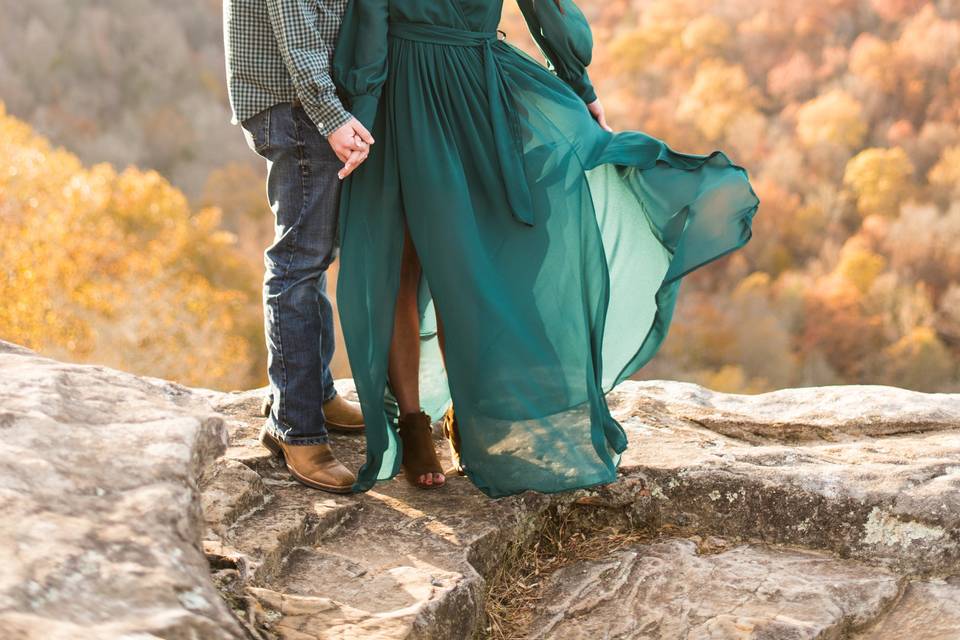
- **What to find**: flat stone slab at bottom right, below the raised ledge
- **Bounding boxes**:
[528,540,899,640]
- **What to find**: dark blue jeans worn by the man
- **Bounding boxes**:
[242,103,340,445]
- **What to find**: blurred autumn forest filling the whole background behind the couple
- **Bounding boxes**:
[0,0,960,391]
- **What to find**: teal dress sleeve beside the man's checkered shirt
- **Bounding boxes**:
[333,0,390,129]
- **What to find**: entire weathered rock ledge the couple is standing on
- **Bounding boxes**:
[0,343,960,640]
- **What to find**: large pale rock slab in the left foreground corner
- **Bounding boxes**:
[0,343,246,640]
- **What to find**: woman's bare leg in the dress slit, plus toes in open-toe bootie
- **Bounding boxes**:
[388,226,445,485]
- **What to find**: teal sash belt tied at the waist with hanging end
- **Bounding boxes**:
[390,22,534,226]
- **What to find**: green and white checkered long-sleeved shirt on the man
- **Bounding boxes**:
[223,0,351,136]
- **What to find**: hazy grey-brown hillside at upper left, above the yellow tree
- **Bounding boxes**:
[0,0,251,197]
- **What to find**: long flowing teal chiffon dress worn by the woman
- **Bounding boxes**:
[334,0,758,496]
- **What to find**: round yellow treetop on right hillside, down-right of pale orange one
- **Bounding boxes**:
[843,147,913,217]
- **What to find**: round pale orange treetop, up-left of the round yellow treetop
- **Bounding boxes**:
[797,90,867,149]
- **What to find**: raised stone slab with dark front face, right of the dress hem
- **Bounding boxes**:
[595,382,960,574]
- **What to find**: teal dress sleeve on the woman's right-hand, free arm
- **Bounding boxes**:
[517,0,597,103]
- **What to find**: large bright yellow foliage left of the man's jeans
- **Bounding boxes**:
[0,107,259,388]
